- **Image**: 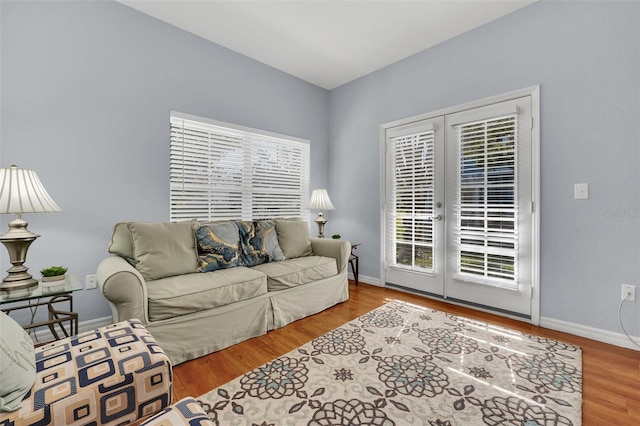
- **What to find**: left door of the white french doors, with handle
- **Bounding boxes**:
[385,117,445,295]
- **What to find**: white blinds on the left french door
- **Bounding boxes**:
[387,128,435,272]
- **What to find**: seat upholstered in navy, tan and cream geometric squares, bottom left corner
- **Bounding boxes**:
[0,319,173,426]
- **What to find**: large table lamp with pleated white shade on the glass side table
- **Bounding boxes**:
[0,165,62,290]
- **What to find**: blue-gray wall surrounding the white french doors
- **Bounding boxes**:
[327,2,640,335]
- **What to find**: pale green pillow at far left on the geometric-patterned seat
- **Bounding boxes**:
[0,311,36,412]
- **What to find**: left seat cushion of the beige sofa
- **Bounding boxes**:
[147,266,267,321]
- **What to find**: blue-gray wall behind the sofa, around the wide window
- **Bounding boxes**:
[0,0,329,321]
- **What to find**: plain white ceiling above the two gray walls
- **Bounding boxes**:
[119,0,535,89]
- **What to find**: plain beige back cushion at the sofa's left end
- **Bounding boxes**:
[129,221,198,281]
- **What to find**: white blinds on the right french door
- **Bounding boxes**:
[455,114,518,289]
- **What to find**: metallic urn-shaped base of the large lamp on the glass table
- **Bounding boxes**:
[0,215,40,290]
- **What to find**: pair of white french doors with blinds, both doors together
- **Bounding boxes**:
[383,90,537,321]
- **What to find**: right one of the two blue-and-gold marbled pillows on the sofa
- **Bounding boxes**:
[236,220,284,266]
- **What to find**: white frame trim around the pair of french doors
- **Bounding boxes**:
[379,85,540,325]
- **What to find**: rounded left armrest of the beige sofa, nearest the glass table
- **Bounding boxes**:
[96,256,149,325]
